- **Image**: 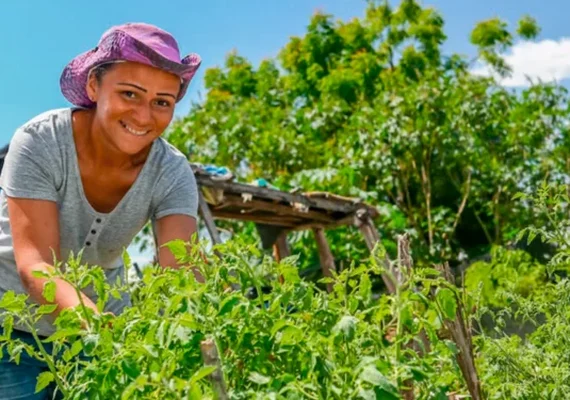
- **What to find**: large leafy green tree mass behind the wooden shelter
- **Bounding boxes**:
[168,0,570,272]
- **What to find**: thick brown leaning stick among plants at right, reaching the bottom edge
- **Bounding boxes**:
[436,263,483,400]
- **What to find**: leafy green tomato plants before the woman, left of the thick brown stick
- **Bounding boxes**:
[0,241,463,399]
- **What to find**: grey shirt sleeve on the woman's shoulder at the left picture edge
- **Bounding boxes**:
[0,129,58,201]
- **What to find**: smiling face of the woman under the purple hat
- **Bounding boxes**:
[87,62,180,155]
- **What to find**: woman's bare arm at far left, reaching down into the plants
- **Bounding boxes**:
[7,197,97,318]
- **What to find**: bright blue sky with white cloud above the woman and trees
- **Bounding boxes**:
[0,0,570,266]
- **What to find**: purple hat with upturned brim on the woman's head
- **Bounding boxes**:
[59,23,202,108]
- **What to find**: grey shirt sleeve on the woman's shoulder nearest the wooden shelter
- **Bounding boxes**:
[153,160,198,220]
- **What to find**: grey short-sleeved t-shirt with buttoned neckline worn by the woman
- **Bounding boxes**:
[0,108,198,336]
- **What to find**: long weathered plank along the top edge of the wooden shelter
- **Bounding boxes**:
[196,174,362,213]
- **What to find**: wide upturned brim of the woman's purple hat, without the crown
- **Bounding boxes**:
[60,31,202,108]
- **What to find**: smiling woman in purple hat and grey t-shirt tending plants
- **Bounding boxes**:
[0,23,200,399]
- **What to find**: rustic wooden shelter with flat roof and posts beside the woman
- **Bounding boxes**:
[192,165,382,291]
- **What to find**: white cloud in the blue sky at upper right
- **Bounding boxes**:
[472,38,570,87]
